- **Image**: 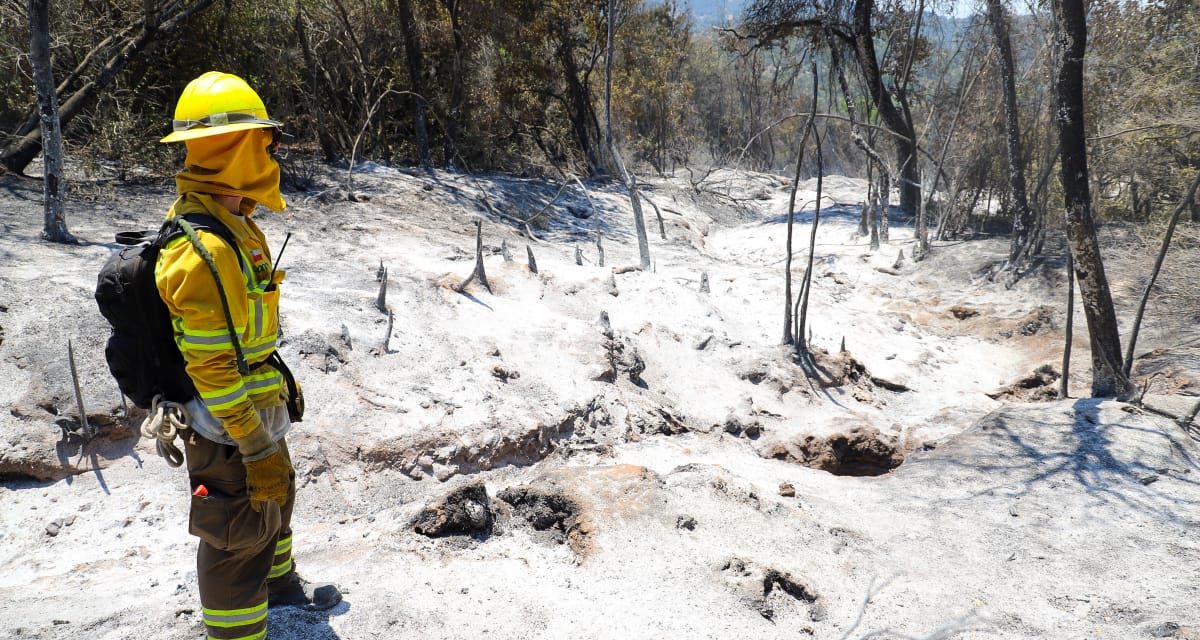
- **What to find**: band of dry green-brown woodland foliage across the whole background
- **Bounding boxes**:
[0,0,1200,200]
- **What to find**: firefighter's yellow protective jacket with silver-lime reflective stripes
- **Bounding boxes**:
[155,192,287,441]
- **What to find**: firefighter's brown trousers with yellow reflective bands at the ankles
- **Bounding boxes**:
[185,431,295,640]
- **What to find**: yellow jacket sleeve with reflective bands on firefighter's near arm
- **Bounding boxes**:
[155,231,262,442]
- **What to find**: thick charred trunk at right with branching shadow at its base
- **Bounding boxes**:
[1052,0,1133,396]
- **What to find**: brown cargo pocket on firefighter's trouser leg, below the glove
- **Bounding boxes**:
[187,492,281,551]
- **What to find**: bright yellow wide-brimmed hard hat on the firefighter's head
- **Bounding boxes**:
[158,71,283,142]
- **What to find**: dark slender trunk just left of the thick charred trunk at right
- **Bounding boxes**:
[988,0,1036,269]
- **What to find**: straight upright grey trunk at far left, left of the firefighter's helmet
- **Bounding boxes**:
[29,0,74,243]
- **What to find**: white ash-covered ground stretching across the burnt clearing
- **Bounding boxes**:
[0,166,1200,640]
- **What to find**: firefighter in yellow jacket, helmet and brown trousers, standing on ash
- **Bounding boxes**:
[155,72,341,640]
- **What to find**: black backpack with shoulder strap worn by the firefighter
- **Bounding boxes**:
[96,214,250,408]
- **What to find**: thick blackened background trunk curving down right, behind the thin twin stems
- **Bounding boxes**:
[854,0,920,216]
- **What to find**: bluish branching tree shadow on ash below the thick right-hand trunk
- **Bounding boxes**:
[910,399,1200,526]
